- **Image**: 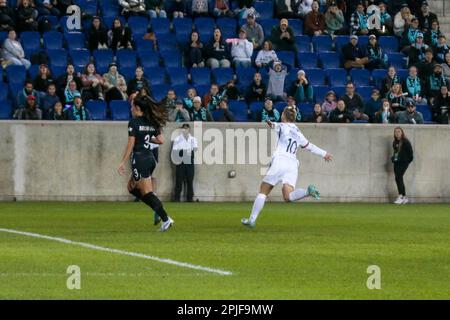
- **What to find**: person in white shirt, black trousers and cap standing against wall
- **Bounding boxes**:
[172,123,198,202]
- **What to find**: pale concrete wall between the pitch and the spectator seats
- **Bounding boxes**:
[0,121,450,202]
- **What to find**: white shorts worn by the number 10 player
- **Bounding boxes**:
[263,156,298,188]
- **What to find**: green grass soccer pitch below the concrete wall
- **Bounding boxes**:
[0,202,450,299]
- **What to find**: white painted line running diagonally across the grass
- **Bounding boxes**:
[0,228,233,276]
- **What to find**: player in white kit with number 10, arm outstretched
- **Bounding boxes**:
[241,106,333,228]
